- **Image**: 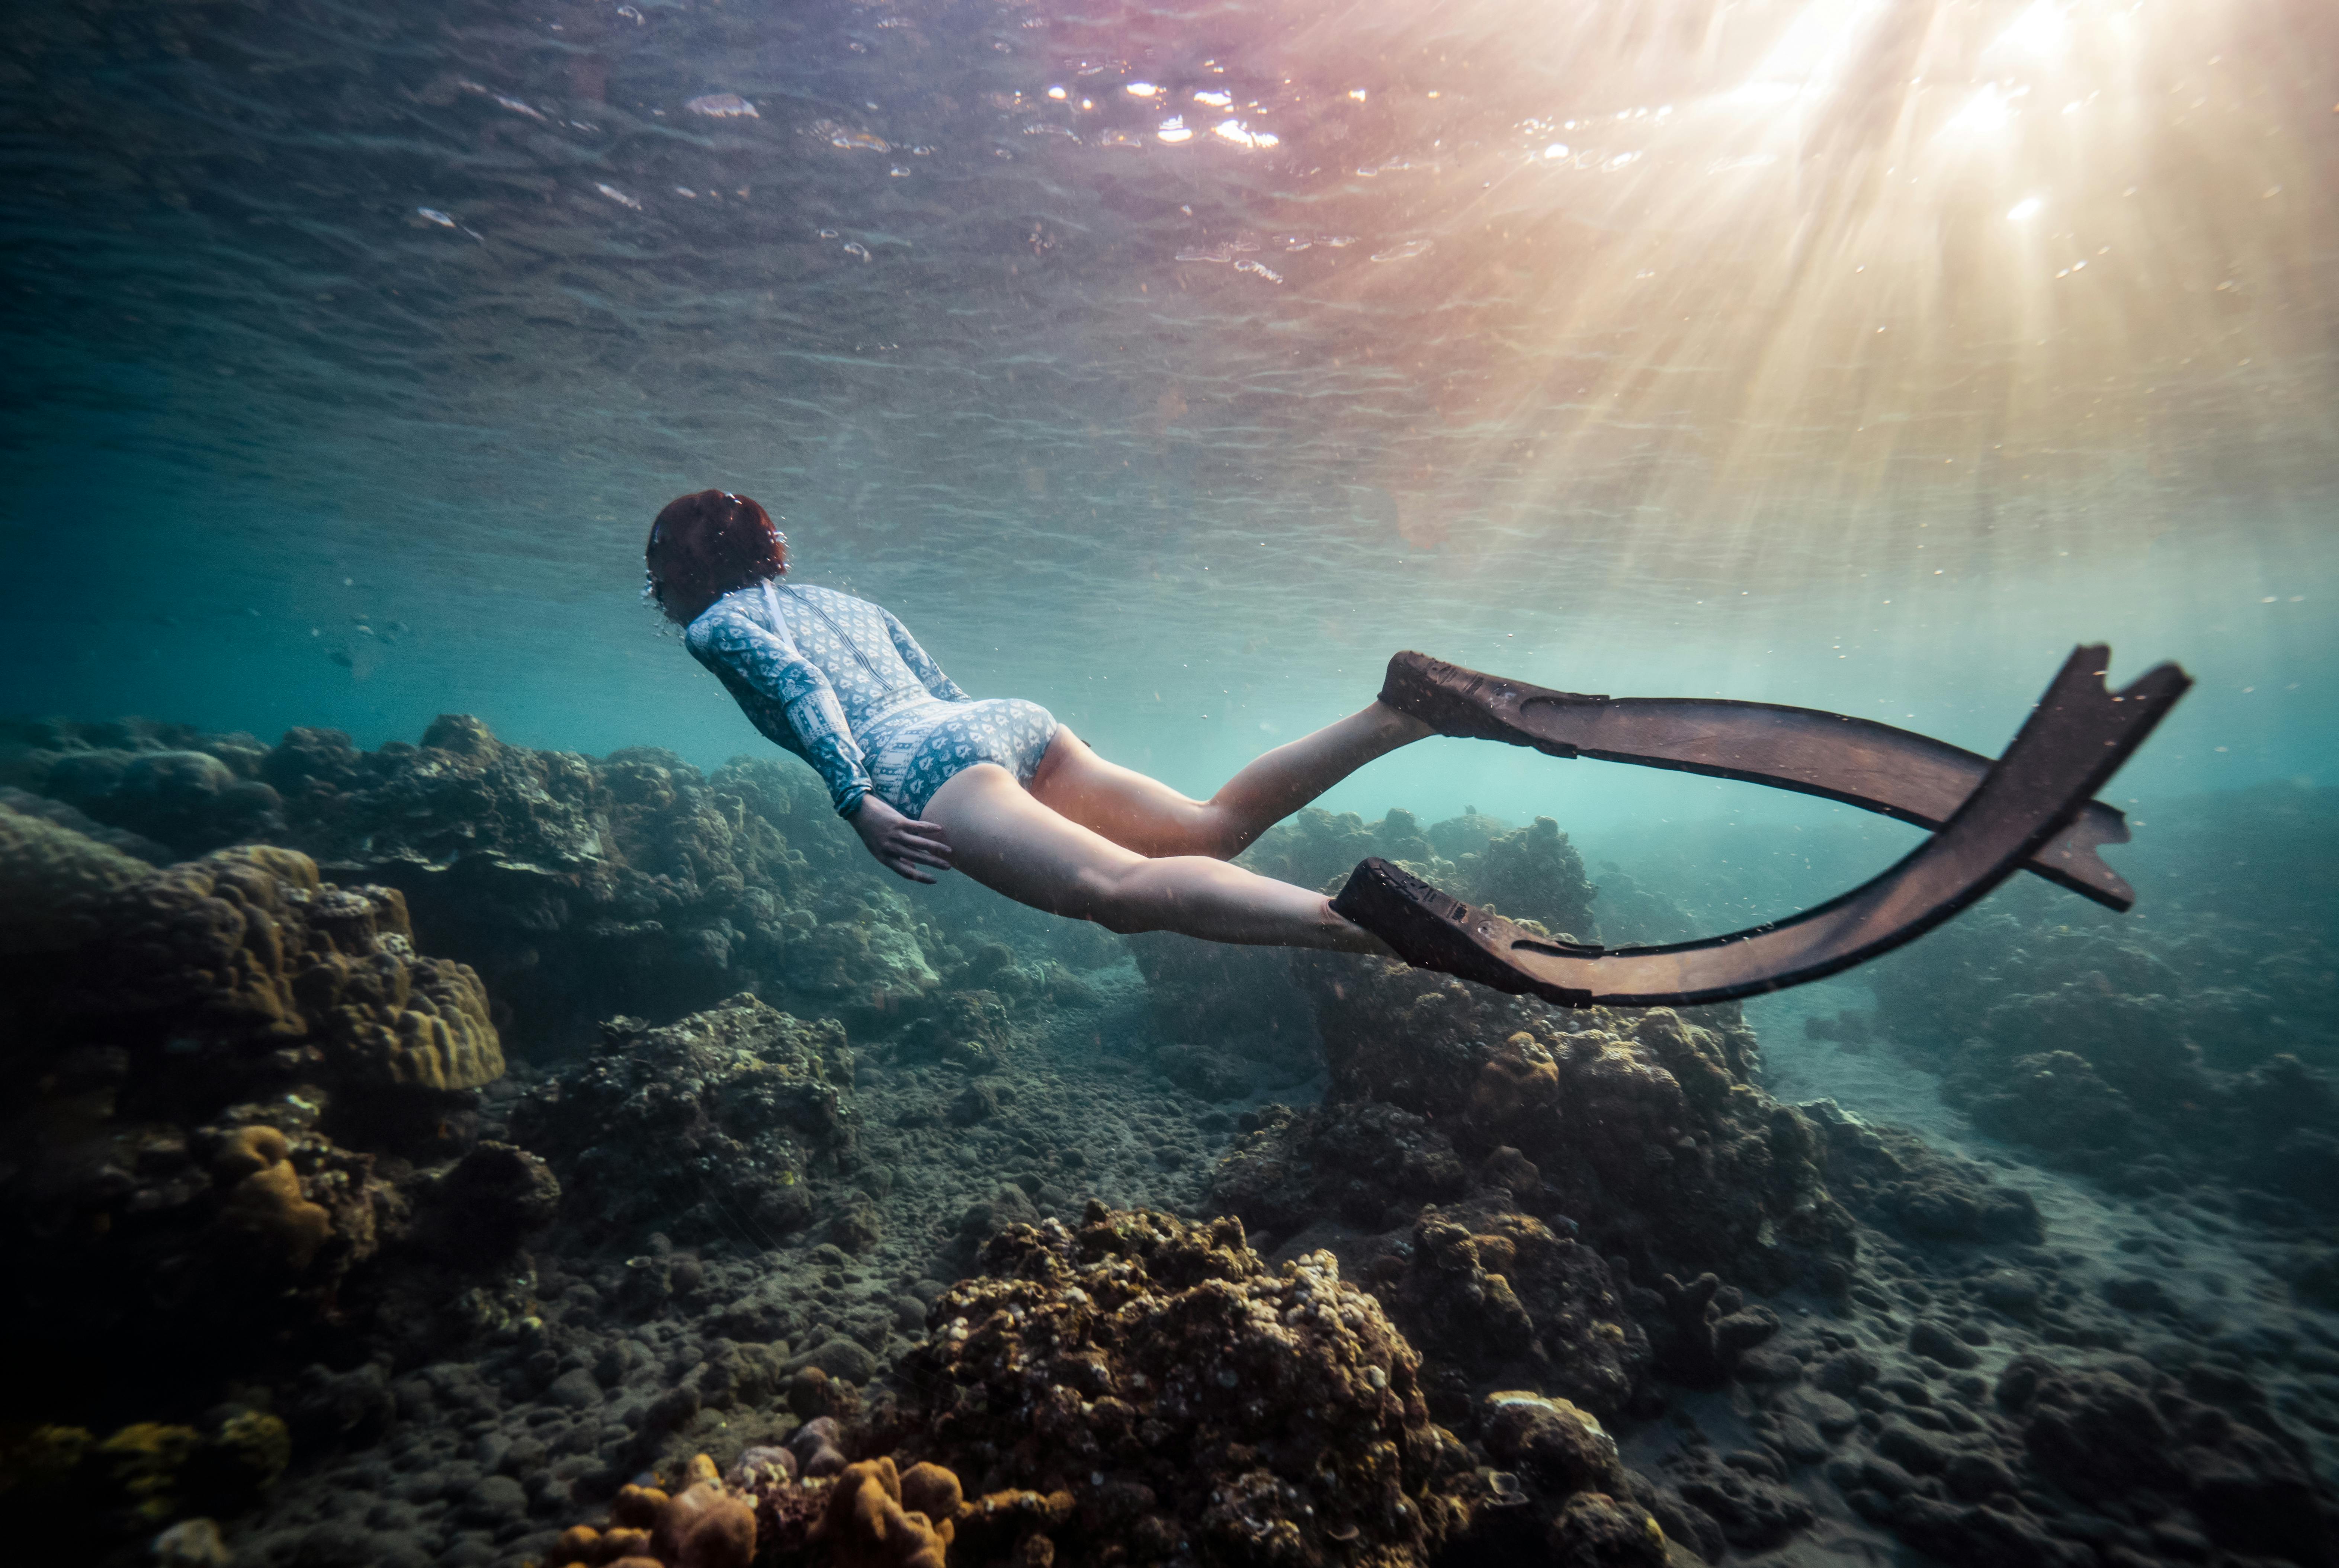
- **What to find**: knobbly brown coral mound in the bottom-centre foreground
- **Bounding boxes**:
[910,1203,1464,1566]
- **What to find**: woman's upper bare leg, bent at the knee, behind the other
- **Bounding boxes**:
[1034,702,1431,861]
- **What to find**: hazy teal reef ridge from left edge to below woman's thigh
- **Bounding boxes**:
[0,714,1120,1048]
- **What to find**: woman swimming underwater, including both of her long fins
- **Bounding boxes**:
[645,489,2192,1006]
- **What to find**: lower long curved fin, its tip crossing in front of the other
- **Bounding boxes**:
[1333,646,2192,1006]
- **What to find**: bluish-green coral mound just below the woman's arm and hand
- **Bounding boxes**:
[264,730,968,1058]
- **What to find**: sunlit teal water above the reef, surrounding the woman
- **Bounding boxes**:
[0,0,2339,840]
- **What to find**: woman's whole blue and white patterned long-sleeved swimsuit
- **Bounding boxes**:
[683,583,1057,817]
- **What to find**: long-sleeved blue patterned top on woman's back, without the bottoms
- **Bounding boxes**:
[683,583,973,817]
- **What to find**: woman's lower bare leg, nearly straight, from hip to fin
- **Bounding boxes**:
[924,763,1387,952]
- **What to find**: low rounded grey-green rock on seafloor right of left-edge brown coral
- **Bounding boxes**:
[510,995,854,1245]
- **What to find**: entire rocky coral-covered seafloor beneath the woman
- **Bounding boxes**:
[0,716,2339,1568]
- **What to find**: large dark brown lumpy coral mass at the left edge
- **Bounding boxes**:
[0,822,557,1552]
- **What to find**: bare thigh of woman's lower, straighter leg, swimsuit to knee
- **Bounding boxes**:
[924,763,1144,920]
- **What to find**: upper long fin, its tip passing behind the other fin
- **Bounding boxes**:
[1380,653,2136,910]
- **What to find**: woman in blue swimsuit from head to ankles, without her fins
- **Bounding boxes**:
[643,489,1431,952]
